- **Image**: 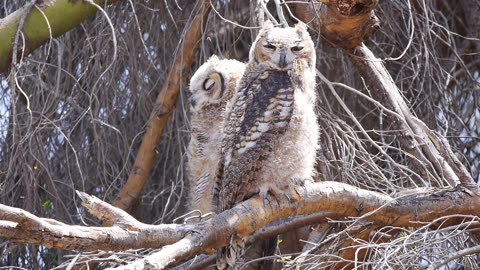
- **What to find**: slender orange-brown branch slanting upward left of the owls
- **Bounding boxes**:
[113,0,211,210]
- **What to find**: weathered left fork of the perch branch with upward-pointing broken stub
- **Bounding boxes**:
[0,192,189,251]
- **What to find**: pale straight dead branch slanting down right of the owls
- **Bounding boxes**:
[351,45,478,192]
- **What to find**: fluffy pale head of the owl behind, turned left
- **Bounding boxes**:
[189,55,245,113]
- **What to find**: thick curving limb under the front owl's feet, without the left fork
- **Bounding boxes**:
[109,182,480,269]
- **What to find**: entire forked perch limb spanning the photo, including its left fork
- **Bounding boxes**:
[0,182,480,269]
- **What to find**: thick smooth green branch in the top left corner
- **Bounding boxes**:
[0,0,119,73]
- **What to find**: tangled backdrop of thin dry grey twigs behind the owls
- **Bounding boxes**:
[0,0,480,269]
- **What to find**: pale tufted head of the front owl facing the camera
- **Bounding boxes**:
[250,21,315,70]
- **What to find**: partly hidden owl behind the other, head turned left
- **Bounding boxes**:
[187,55,245,221]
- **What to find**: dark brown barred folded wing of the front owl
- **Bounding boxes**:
[217,70,294,211]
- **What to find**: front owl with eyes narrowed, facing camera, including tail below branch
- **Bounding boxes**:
[216,23,319,269]
